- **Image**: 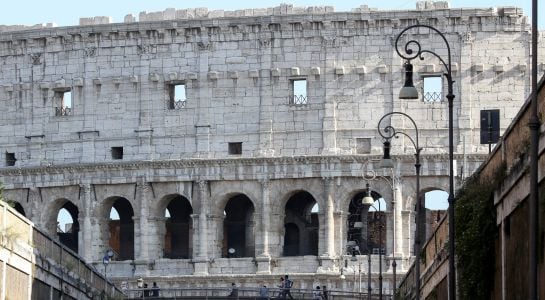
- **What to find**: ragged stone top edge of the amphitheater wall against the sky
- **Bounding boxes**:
[0,1,530,36]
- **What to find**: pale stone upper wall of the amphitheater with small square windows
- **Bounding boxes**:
[0,2,543,166]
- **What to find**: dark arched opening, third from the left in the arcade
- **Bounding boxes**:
[164,195,193,259]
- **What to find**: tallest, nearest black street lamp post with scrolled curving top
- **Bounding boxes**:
[395,24,456,300]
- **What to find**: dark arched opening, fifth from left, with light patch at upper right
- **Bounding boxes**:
[283,191,319,256]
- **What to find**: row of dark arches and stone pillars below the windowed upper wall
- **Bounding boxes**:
[3,179,446,276]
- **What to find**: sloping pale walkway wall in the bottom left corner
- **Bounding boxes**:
[0,201,123,300]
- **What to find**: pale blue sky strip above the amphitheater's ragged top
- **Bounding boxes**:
[0,0,545,30]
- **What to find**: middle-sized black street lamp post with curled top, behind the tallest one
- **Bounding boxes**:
[378,111,425,300]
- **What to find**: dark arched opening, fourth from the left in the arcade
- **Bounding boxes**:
[222,194,255,257]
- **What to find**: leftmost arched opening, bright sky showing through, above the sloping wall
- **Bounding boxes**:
[57,201,79,253]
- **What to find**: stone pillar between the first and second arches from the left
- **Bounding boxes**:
[78,184,94,262]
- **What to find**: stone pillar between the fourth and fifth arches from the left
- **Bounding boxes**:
[256,179,271,274]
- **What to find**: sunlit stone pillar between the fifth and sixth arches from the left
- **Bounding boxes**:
[317,177,335,273]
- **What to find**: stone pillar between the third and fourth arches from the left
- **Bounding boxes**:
[192,180,209,275]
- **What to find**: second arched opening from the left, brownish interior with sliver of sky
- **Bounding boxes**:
[102,196,134,260]
